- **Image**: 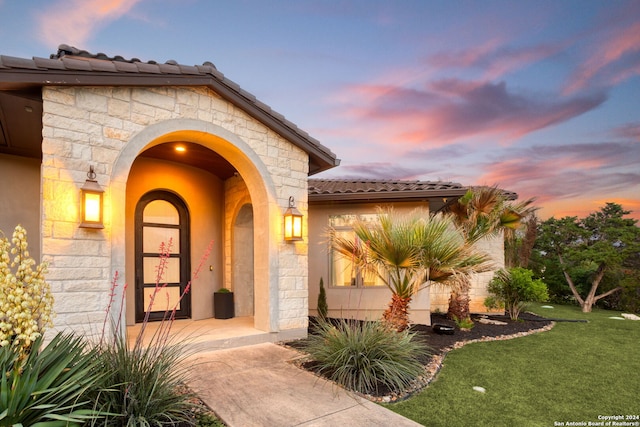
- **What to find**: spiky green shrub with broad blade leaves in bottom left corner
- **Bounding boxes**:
[0,334,103,426]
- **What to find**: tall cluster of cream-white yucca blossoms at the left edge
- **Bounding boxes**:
[0,225,53,352]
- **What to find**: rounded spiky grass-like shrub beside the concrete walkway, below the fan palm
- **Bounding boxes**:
[305,320,428,393]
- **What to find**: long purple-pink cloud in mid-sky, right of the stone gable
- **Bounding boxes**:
[344,79,606,146]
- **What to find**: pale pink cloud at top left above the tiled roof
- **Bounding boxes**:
[36,0,141,48]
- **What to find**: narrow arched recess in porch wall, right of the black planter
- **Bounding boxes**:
[231,204,254,316]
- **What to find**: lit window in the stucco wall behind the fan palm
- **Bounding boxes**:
[329,214,385,288]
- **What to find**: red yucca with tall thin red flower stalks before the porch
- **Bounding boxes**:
[95,241,213,426]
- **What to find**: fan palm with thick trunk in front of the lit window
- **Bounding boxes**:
[329,210,489,331]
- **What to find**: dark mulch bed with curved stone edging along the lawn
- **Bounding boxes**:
[285,313,554,403]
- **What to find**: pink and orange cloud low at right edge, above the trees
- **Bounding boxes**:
[476,142,640,218]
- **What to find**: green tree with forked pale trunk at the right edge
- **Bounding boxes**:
[533,203,640,313]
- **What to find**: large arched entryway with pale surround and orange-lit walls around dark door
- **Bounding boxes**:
[110,119,282,332]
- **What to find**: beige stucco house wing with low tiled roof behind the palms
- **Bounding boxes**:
[309,178,510,325]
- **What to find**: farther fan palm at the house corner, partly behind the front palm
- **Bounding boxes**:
[445,186,536,319]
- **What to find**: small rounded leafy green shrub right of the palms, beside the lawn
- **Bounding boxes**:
[485,267,549,320]
